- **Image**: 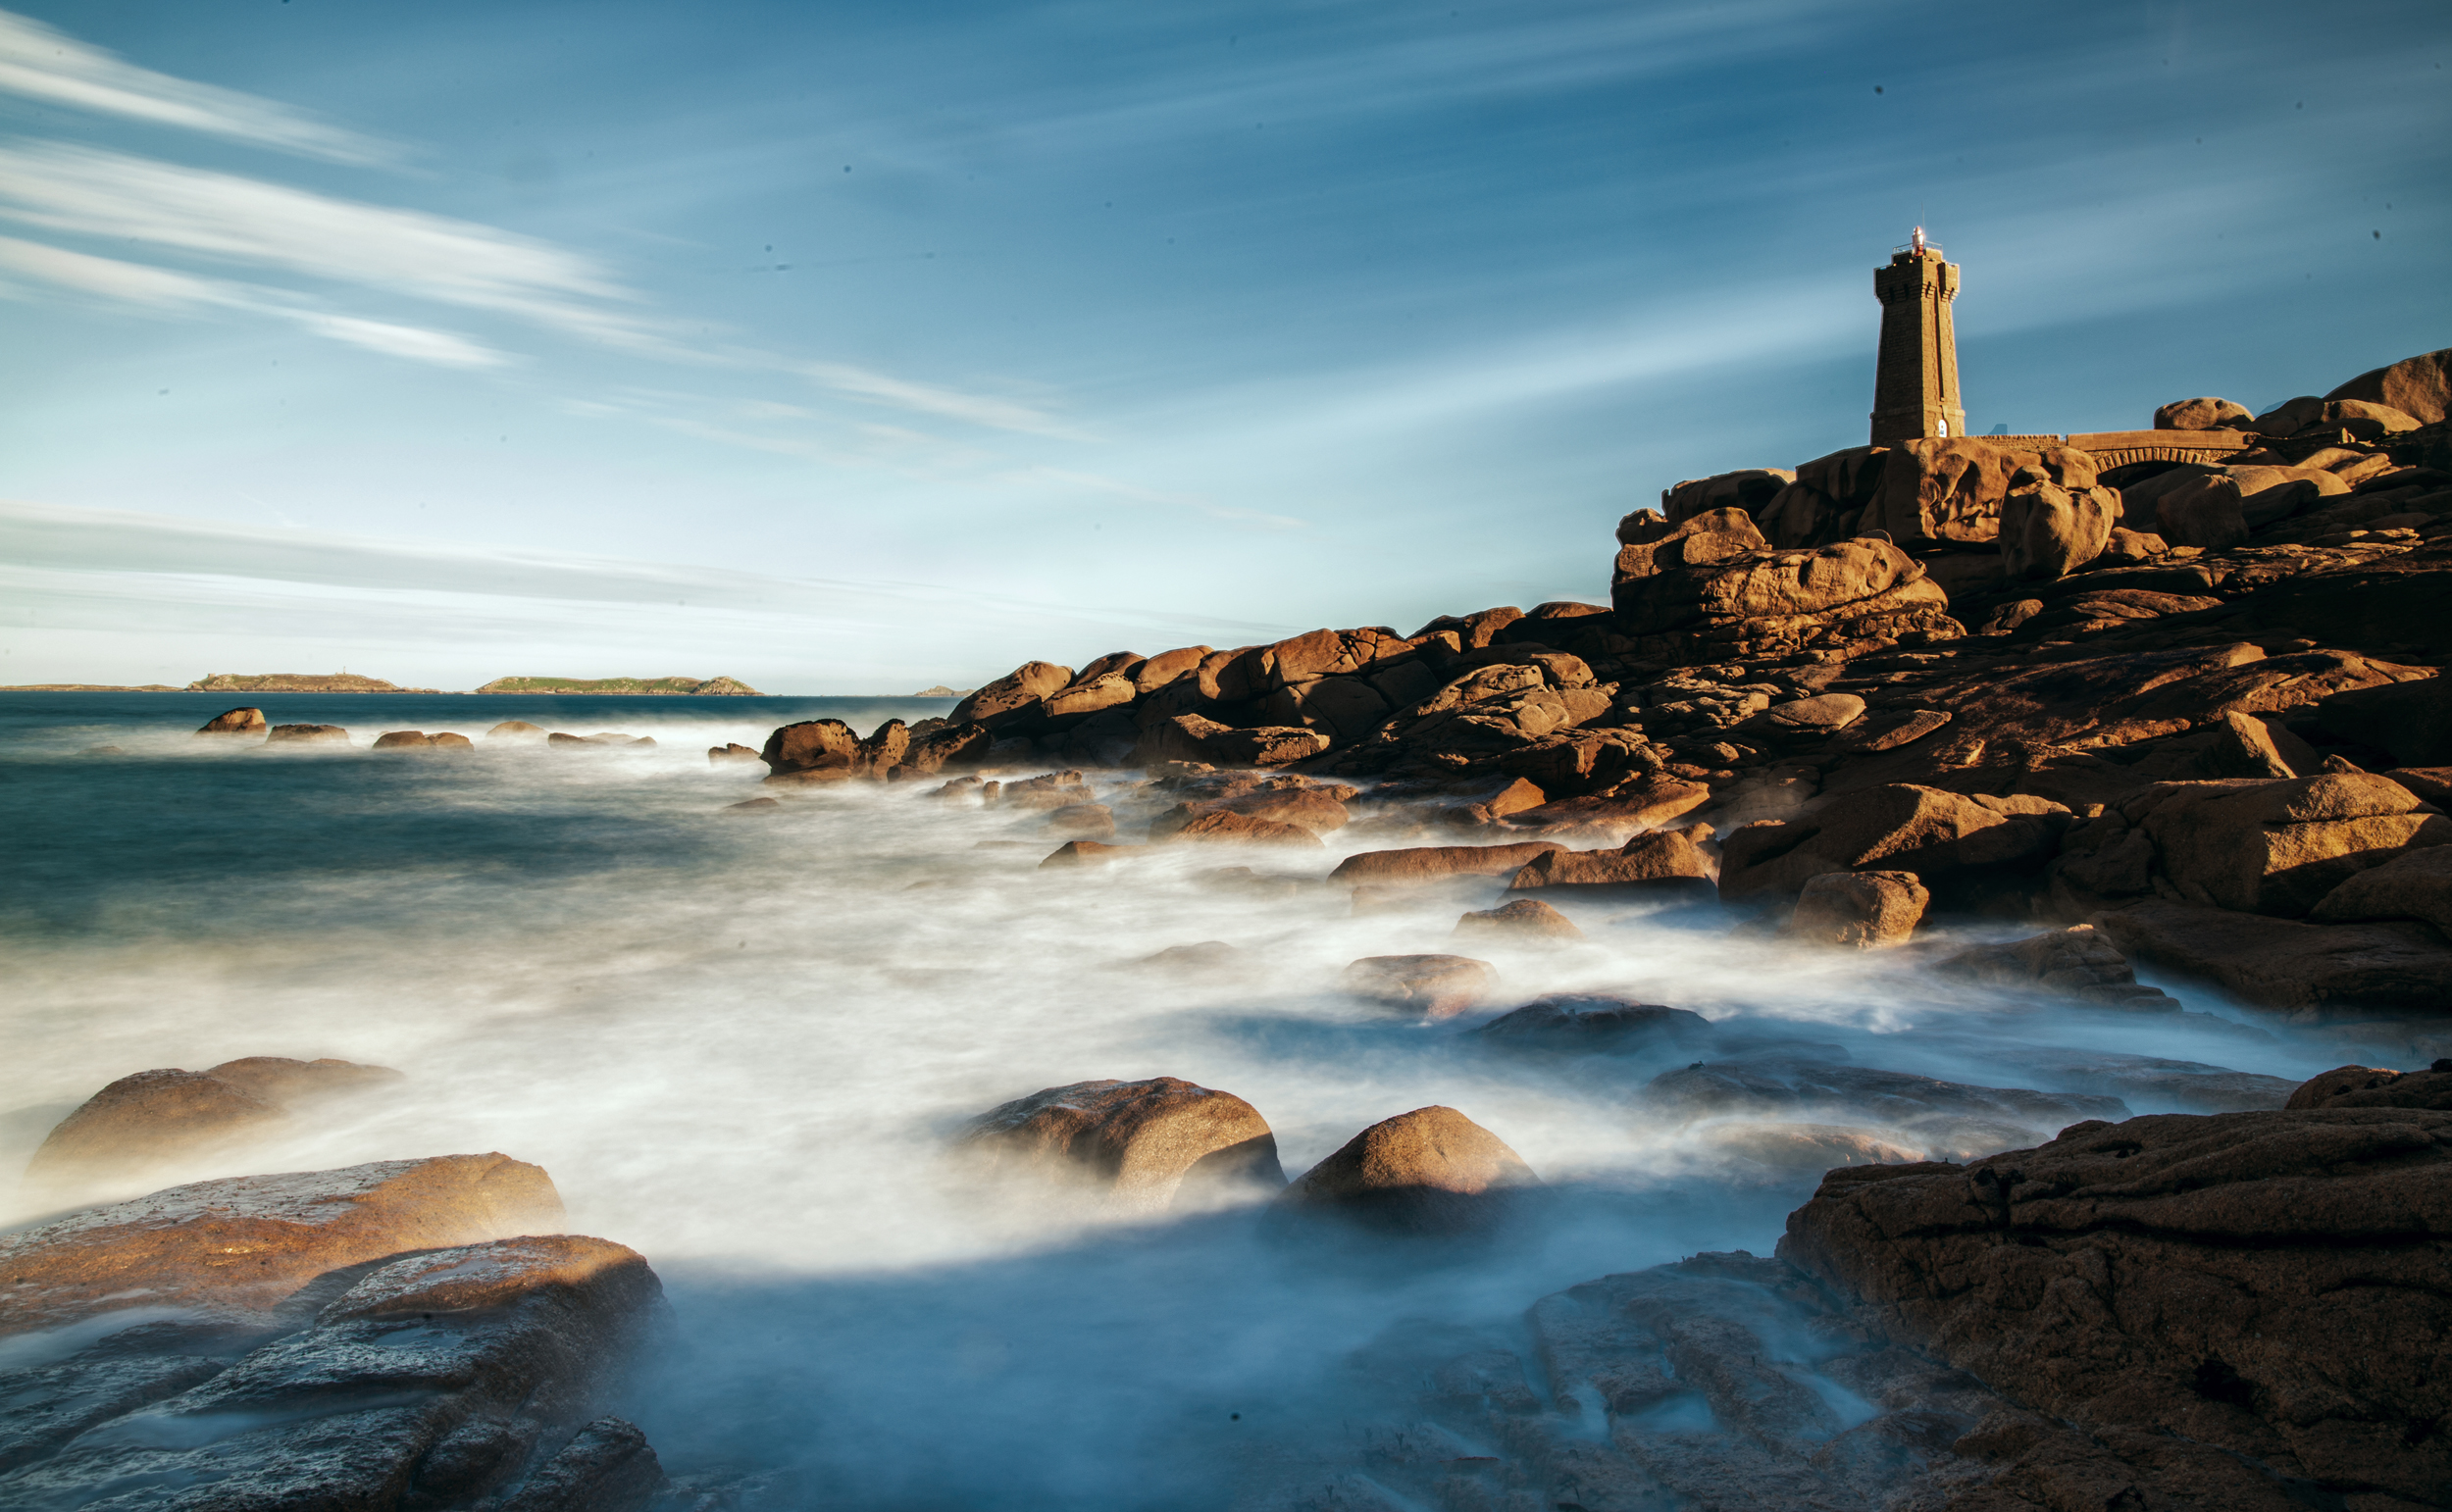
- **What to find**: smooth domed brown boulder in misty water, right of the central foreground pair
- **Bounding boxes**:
[1278,1105,1540,1237]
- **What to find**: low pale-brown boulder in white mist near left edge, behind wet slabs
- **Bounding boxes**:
[27,1056,402,1191]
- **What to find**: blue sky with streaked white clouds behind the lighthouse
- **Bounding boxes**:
[0,0,2452,693]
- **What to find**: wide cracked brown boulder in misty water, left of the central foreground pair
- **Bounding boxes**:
[961,1076,1285,1208]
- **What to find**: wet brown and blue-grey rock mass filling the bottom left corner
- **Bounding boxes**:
[0,1157,667,1510]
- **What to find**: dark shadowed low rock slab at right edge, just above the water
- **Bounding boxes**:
[2094,899,2452,1017]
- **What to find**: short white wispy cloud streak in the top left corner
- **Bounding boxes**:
[0,10,400,164]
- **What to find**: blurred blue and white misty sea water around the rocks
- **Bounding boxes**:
[0,693,2347,1507]
